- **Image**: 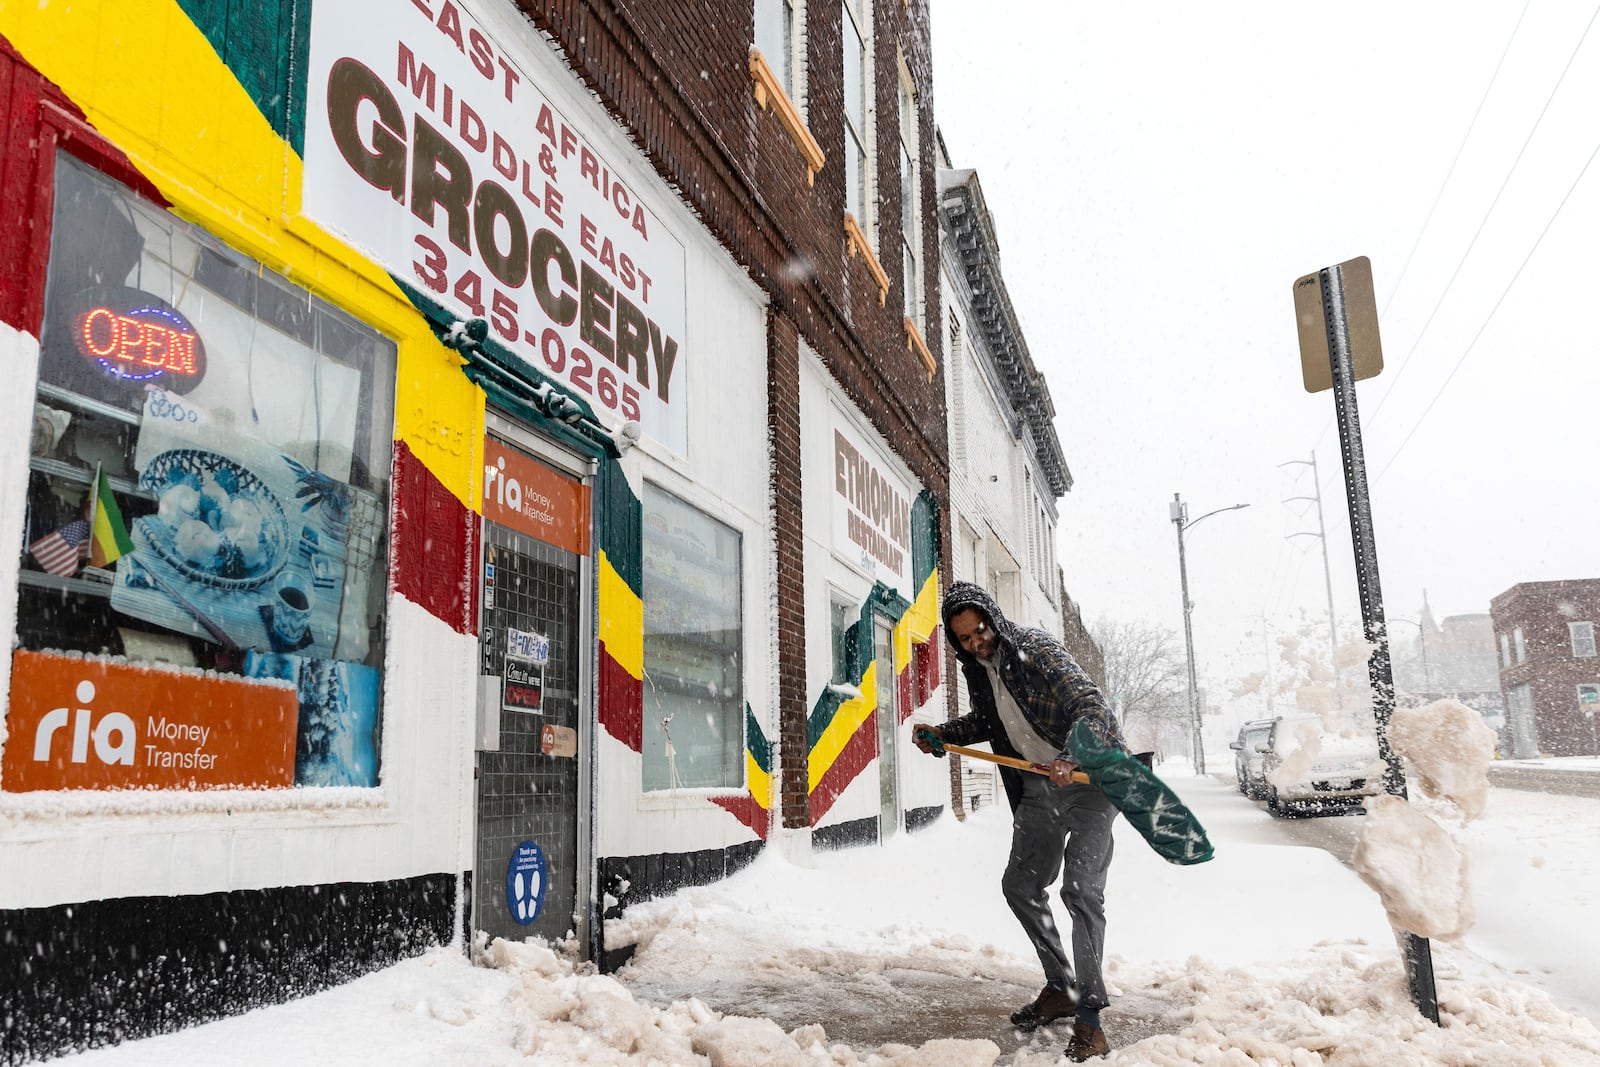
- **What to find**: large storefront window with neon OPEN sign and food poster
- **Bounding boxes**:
[14,154,395,790]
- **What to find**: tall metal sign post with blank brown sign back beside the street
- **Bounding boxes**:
[1294,256,1438,1025]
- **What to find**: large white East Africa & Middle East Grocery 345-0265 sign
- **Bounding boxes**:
[302,0,688,454]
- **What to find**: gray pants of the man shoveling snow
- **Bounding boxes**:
[1000,774,1117,1008]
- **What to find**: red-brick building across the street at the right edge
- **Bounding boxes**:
[1490,577,1600,758]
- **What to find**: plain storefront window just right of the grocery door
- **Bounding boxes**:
[643,486,744,790]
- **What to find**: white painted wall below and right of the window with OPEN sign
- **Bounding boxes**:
[0,585,477,909]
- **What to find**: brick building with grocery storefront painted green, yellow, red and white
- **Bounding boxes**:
[0,0,950,1061]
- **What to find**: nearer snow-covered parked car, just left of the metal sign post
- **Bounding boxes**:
[1261,717,1384,816]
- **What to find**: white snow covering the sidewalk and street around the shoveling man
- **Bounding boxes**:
[56,761,1600,1067]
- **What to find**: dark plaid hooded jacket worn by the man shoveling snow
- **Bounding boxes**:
[939,582,1126,808]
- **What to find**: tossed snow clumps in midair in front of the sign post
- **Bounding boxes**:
[1354,701,1494,941]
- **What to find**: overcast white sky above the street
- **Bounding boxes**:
[933,0,1600,716]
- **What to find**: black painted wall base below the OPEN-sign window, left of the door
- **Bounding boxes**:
[0,873,456,1064]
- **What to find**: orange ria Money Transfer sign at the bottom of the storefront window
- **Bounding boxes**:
[0,651,299,793]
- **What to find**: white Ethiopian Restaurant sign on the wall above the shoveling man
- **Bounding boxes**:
[832,414,915,600]
